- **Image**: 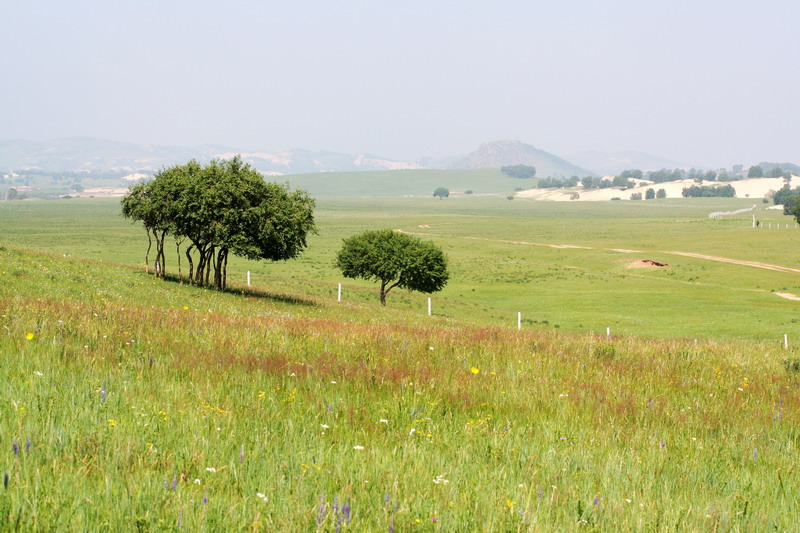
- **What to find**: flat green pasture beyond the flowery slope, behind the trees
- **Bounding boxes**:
[0,195,800,342]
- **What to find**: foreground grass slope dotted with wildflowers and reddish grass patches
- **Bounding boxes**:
[0,249,800,531]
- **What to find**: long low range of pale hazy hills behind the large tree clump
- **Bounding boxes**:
[0,137,421,176]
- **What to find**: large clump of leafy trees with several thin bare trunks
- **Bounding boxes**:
[122,157,315,290]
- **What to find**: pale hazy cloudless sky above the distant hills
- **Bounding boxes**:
[0,0,800,167]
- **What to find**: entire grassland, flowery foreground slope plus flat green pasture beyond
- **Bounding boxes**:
[0,192,800,532]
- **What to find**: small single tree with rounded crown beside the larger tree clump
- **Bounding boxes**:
[336,229,450,305]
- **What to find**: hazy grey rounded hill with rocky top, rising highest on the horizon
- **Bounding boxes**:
[452,140,594,178]
